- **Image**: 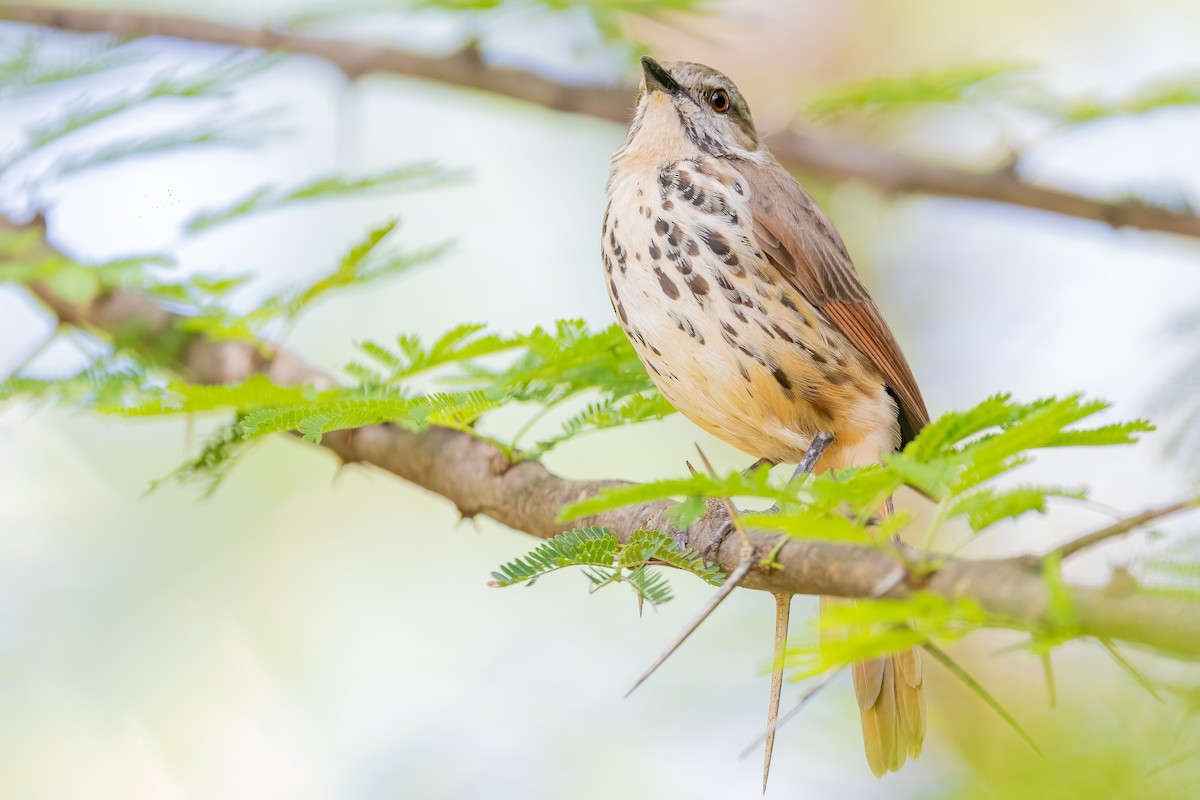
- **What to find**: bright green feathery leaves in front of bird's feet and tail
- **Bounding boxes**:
[559,395,1166,662]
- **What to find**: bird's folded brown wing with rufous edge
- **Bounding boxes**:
[738,160,929,443]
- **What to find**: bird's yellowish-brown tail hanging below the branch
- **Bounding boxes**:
[821,597,925,777]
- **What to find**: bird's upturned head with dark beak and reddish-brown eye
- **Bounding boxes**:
[625,55,758,161]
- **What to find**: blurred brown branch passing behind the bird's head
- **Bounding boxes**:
[7,1,1200,236]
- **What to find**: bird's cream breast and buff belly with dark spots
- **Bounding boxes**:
[602,154,899,468]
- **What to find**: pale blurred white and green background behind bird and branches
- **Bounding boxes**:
[0,0,1200,799]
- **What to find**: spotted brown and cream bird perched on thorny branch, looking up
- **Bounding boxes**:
[601,56,929,790]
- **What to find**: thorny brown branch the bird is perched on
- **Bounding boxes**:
[0,214,1200,656]
